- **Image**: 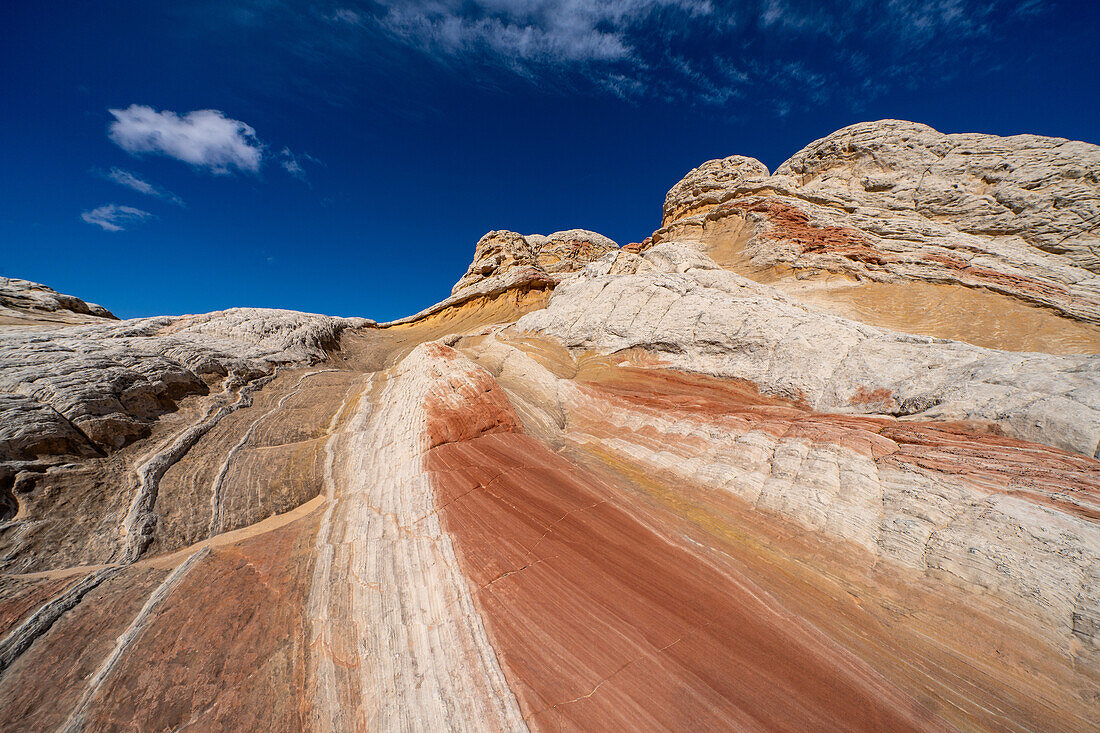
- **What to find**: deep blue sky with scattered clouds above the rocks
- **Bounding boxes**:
[0,0,1100,320]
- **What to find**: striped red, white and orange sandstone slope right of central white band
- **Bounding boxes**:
[429,335,1098,730]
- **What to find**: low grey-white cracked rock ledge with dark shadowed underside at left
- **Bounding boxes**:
[0,308,362,459]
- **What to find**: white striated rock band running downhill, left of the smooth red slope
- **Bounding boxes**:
[308,347,527,731]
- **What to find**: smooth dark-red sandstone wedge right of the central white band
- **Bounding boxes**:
[428,429,946,731]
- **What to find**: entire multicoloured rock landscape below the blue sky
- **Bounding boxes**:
[0,121,1100,731]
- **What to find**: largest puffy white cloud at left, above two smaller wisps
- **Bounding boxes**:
[108,105,264,174]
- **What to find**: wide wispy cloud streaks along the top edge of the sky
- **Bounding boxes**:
[323,0,1047,112]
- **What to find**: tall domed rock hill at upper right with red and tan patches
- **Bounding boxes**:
[650,120,1100,351]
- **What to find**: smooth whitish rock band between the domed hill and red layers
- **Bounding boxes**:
[517,242,1100,457]
